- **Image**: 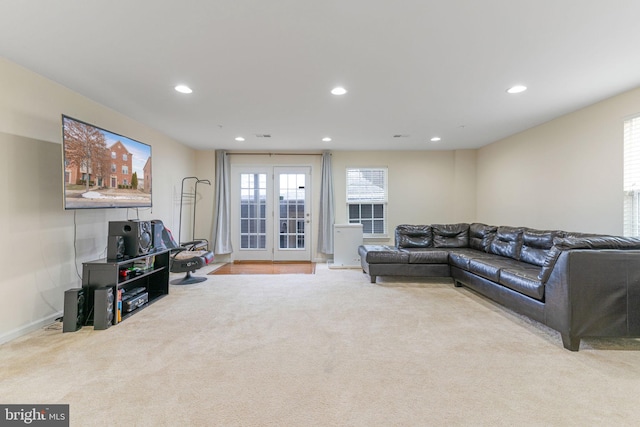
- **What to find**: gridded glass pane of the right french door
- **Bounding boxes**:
[278,173,306,249]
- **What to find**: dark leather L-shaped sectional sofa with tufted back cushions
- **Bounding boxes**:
[358,223,640,351]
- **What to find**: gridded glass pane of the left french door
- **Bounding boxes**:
[240,173,267,249]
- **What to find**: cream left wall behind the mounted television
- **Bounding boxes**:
[0,58,197,342]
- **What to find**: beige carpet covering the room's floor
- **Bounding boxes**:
[0,265,640,426]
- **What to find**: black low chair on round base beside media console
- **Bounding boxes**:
[151,220,214,285]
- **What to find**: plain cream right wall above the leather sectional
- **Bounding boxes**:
[477,85,640,235]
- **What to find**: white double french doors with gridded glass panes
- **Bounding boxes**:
[231,165,311,261]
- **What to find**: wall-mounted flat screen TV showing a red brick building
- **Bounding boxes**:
[62,115,152,209]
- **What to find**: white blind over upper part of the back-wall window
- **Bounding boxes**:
[347,168,387,203]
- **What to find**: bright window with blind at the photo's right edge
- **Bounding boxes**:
[623,116,640,237]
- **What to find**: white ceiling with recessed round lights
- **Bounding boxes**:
[0,0,640,151]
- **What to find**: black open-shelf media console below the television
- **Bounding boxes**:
[82,249,170,329]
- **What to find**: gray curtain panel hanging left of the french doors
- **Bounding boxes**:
[212,150,233,254]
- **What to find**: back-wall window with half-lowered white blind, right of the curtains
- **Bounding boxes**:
[347,168,387,237]
